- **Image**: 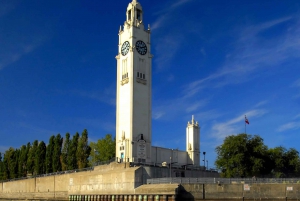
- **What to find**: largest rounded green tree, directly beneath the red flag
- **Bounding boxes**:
[215,134,269,177]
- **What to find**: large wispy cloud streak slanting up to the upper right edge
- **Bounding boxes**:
[180,17,300,95]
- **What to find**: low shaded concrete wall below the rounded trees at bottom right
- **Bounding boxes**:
[181,184,300,200]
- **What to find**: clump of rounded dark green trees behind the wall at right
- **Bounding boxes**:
[215,134,300,177]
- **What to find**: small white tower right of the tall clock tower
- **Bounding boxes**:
[186,115,200,166]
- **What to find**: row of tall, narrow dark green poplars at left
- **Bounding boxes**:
[0,129,91,180]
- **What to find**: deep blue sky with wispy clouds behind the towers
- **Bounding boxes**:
[0,0,300,166]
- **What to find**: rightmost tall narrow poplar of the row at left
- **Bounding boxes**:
[76,129,91,169]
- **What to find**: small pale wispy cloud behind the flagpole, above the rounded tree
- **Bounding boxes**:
[212,109,267,140]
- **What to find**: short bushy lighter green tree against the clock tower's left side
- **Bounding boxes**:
[90,134,116,165]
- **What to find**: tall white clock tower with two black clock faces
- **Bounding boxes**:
[116,0,153,162]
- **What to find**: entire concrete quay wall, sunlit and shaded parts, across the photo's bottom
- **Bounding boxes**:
[5,163,300,200]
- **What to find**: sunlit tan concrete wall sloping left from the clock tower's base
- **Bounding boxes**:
[0,163,142,199]
